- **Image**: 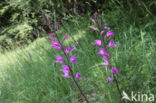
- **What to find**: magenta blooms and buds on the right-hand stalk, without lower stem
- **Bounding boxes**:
[90,15,118,82]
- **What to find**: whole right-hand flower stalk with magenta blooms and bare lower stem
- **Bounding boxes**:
[90,12,126,103]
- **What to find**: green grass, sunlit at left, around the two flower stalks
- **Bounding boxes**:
[0,13,156,103]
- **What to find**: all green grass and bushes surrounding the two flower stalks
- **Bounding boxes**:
[0,0,156,103]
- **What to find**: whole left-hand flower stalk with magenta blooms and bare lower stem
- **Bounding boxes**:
[49,24,89,103]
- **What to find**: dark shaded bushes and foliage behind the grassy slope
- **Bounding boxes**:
[0,0,156,49]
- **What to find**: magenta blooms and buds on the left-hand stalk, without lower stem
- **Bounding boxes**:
[49,24,82,79]
